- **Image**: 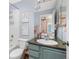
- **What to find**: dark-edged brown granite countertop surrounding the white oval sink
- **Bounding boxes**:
[28,38,66,51]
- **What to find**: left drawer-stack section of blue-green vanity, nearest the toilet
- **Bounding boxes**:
[29,44,40,59]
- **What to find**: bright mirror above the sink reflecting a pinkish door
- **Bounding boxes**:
[40,13,55,39]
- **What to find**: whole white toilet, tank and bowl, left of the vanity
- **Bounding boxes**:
[10,39,28,59]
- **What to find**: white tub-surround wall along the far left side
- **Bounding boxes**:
[9,8,19,47]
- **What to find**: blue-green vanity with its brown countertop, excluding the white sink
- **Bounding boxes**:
[29,39,66,59]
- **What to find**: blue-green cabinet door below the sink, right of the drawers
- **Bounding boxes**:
[42,50,66,59]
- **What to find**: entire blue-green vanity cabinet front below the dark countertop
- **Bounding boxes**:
[29,44,66,59]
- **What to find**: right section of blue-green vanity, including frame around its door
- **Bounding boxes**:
[41,47,66,59]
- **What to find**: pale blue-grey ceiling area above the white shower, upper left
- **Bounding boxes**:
[9,0,35,11]
